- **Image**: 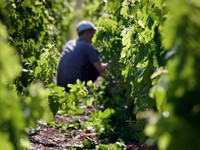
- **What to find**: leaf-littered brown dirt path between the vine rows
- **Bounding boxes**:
[29,108,156,150]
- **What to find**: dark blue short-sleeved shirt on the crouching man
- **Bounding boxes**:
[57,40,99,87]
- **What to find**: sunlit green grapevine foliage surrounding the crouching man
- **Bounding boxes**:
[0,0,200,150]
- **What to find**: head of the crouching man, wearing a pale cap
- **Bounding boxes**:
[76,20,96,43]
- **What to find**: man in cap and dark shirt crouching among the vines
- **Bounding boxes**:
[57,20,107,91]
